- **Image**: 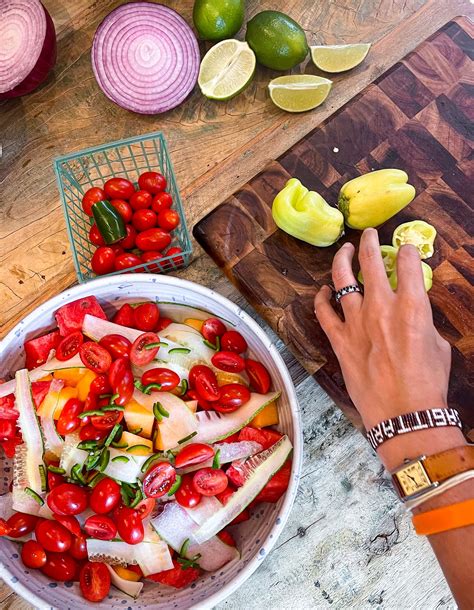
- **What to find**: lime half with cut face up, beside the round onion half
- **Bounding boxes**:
[198,39,256,100]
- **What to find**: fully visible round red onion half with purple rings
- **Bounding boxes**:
[92,2,200,114]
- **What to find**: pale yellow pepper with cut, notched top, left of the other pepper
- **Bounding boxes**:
[272,178,344,247]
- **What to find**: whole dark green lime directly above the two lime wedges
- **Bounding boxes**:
[245,11,309,70]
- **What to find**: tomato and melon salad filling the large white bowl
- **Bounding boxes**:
[0,276,300,607]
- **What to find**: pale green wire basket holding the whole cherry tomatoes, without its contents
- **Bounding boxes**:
[54,131,192,283]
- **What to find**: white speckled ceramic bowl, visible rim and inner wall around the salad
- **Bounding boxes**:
[0,274,303,610]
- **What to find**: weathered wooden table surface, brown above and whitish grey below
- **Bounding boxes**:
[0,0,472,610]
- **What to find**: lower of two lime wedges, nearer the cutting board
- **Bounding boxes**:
[268,74,332,112]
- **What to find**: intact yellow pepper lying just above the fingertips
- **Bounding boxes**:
[338,169,415,229]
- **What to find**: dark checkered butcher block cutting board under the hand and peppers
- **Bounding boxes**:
[194,18,474,433]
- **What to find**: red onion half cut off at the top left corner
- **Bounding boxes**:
[0,0,56,99]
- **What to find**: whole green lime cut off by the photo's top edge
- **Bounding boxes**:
[193,0,245,41]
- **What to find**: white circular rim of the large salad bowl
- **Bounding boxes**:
[0,273,303,608]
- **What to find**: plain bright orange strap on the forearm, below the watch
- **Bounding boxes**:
[412,499,474,536]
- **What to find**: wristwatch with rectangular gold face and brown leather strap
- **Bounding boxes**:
[391,445,474,502]
